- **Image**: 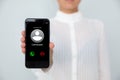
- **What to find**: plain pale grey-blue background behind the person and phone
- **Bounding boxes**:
[0,0,120,80]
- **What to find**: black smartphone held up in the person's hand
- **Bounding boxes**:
[25,18,50,68]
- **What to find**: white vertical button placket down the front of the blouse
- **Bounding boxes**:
[69,22,78,80]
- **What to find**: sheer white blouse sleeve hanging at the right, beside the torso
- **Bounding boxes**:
[99,23,111,80]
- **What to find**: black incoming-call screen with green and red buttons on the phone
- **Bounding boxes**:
[25,20,50,62]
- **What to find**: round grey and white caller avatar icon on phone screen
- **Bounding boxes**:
[31,29,44,43]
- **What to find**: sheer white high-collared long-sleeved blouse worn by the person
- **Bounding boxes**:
[33,11,110,80]
